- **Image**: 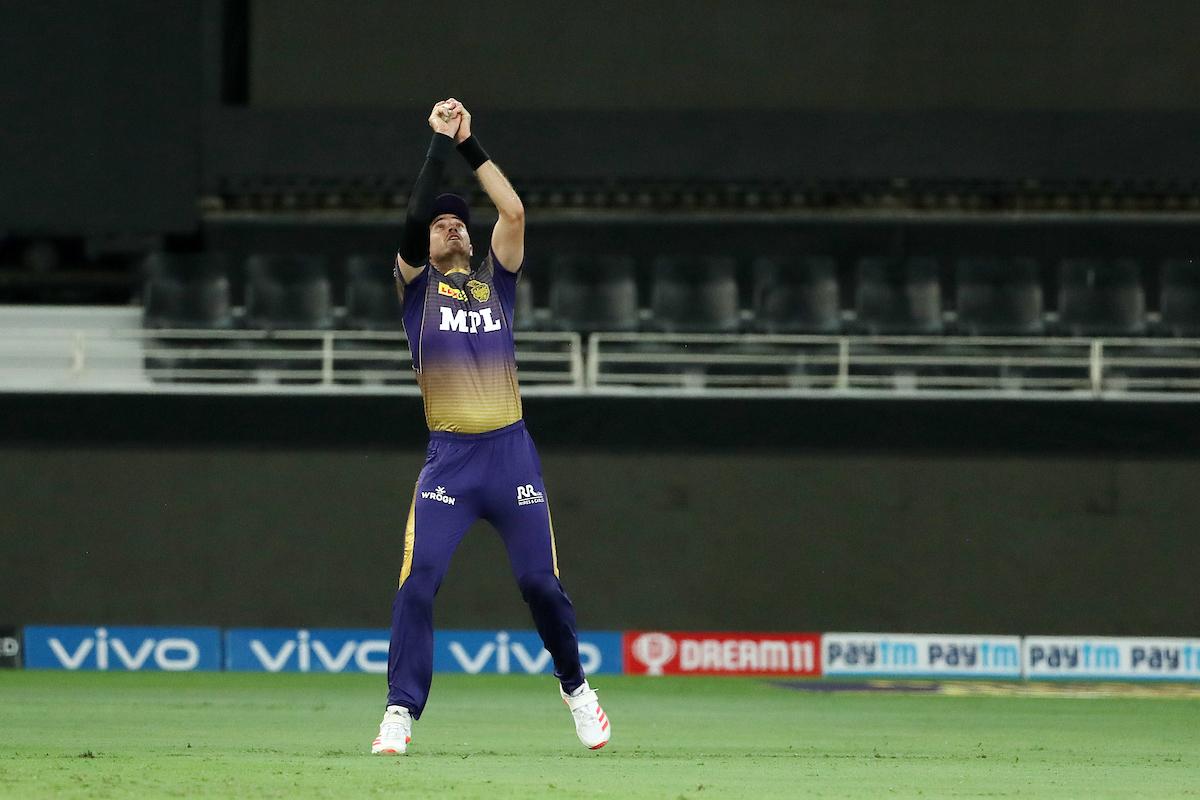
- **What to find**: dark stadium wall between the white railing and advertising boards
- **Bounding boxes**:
[0,395,1200,636]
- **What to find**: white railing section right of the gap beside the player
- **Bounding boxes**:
[587,333,1200,399]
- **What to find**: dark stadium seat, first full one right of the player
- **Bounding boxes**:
[548,255,637,333]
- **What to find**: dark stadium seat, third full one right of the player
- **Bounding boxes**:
[754,255,841,333]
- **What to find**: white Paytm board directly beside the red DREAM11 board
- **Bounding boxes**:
[822,633,1021,678]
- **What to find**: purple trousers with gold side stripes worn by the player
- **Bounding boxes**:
[388,421,584,718]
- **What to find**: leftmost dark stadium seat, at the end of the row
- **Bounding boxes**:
[142,253,234,330]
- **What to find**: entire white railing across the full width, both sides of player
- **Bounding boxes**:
[0,327,1200,401]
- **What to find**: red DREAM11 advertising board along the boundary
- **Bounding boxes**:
[624,631,821,675]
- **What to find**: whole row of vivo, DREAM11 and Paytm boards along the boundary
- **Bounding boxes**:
[14,625,1200,681]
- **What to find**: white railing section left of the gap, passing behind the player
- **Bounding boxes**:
[0,329,584,395]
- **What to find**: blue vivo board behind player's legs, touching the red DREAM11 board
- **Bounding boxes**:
[433,631,622,675]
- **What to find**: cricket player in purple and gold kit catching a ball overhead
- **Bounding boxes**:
[371,98,612,754]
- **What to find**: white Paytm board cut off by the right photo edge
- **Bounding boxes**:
[1025,636,1200,680]
